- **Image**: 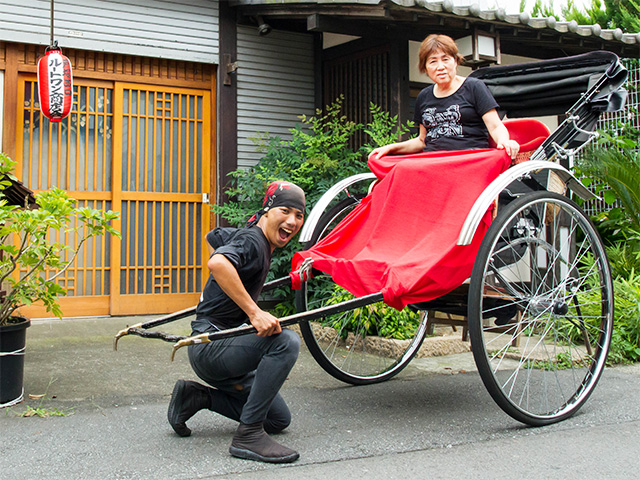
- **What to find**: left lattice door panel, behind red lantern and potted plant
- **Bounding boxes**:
[16,75,113,318]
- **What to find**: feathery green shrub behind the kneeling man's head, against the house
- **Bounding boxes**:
[212,97,411,315]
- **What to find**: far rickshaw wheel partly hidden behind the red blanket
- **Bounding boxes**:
[296,197,426,385]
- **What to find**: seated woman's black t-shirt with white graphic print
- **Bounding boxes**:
[414,77,498,152]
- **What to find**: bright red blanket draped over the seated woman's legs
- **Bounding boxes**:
[292,149,511,310]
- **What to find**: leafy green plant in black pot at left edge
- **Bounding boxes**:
[0,153,120,407]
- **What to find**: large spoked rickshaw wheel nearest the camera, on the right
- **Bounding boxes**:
[468,191,614,426]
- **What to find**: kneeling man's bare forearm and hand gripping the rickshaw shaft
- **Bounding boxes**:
[207,254,282,337]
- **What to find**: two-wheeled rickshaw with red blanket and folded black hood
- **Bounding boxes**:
[114,51,627,426]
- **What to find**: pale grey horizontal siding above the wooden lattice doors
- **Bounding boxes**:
[0,0,219,64]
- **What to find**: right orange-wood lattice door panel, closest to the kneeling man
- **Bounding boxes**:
[111,83,211,315]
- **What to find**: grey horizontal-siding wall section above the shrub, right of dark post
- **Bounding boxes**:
[236,26,315,167]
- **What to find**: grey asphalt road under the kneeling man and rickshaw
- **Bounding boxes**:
[0,319,640,480]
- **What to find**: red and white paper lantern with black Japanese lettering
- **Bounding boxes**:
[38,48,73,122]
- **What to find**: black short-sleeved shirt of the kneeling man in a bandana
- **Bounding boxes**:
[191,226,271,333]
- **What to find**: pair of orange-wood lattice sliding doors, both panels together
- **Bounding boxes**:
[16,75,211,318]
